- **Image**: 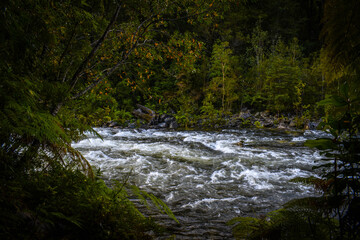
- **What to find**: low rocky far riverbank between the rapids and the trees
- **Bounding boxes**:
[102,110,321,131]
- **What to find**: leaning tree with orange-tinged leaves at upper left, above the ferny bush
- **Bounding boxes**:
[0,0,215,172]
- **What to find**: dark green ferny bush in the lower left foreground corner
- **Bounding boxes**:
[0,165,159,239]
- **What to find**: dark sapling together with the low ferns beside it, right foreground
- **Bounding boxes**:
[230,79,360,239]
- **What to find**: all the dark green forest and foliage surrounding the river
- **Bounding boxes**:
[0,0,360,239]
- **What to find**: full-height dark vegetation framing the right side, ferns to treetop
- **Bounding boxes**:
[229,0,360,240]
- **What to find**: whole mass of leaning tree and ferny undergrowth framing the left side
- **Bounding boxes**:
[0,0,217,239]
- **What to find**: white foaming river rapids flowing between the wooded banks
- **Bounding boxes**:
[73,128,332,239]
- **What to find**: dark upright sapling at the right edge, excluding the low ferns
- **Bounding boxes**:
[307,91,360,239]
